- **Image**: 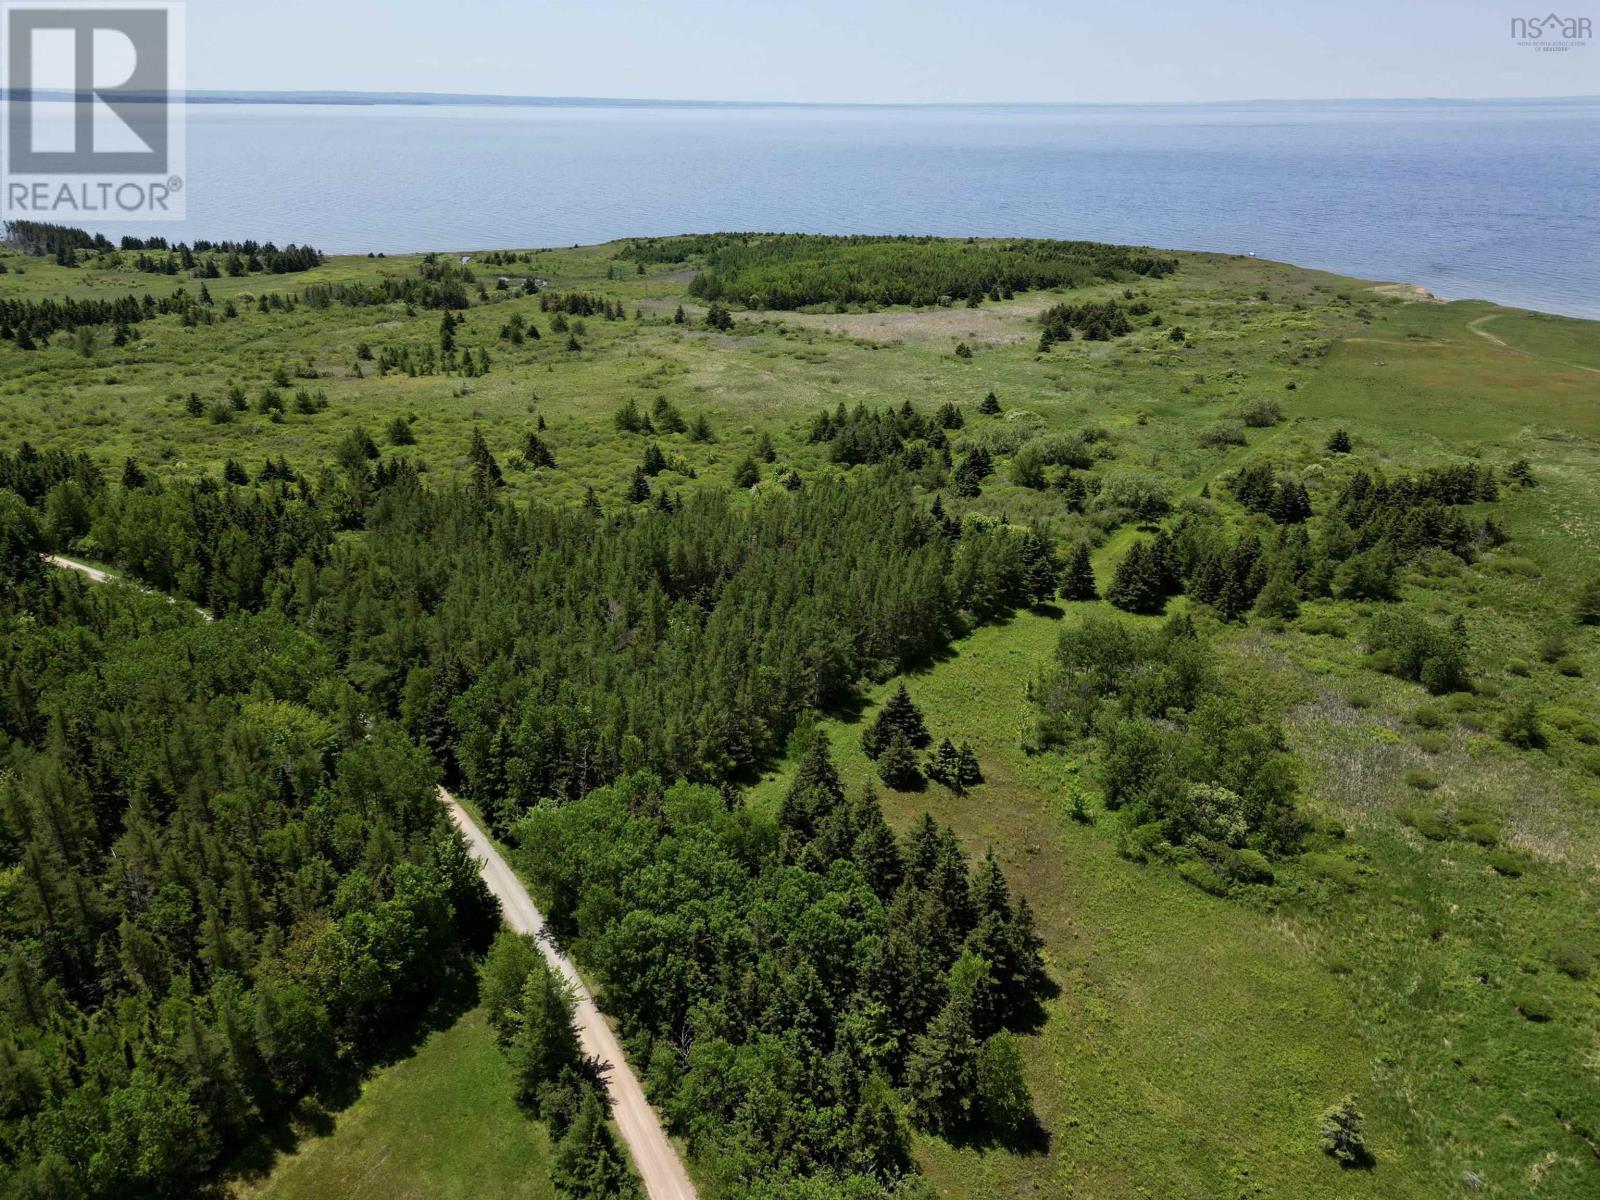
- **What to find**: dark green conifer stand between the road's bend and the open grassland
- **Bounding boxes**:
[12,435,1059,832]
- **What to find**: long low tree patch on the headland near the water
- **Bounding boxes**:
[690,234,1178,309]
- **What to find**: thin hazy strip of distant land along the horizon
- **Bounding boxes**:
[0,88,1600,109]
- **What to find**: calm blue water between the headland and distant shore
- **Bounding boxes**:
[81,101,1600,317]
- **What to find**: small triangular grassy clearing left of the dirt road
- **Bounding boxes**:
[229,1010,554,1200]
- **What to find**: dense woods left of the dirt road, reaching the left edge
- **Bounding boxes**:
[0,572,498,1200]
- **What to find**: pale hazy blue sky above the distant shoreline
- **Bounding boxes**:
[187,0,1600,104]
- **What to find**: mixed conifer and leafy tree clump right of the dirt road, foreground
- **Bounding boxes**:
[515,752,1050,1198]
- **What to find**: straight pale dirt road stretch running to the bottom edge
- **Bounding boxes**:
[438,787,694,1200]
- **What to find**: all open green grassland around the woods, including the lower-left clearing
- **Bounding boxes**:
[0,236,1600,1200]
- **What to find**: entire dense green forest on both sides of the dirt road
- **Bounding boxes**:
[0,428,1045,1195]
